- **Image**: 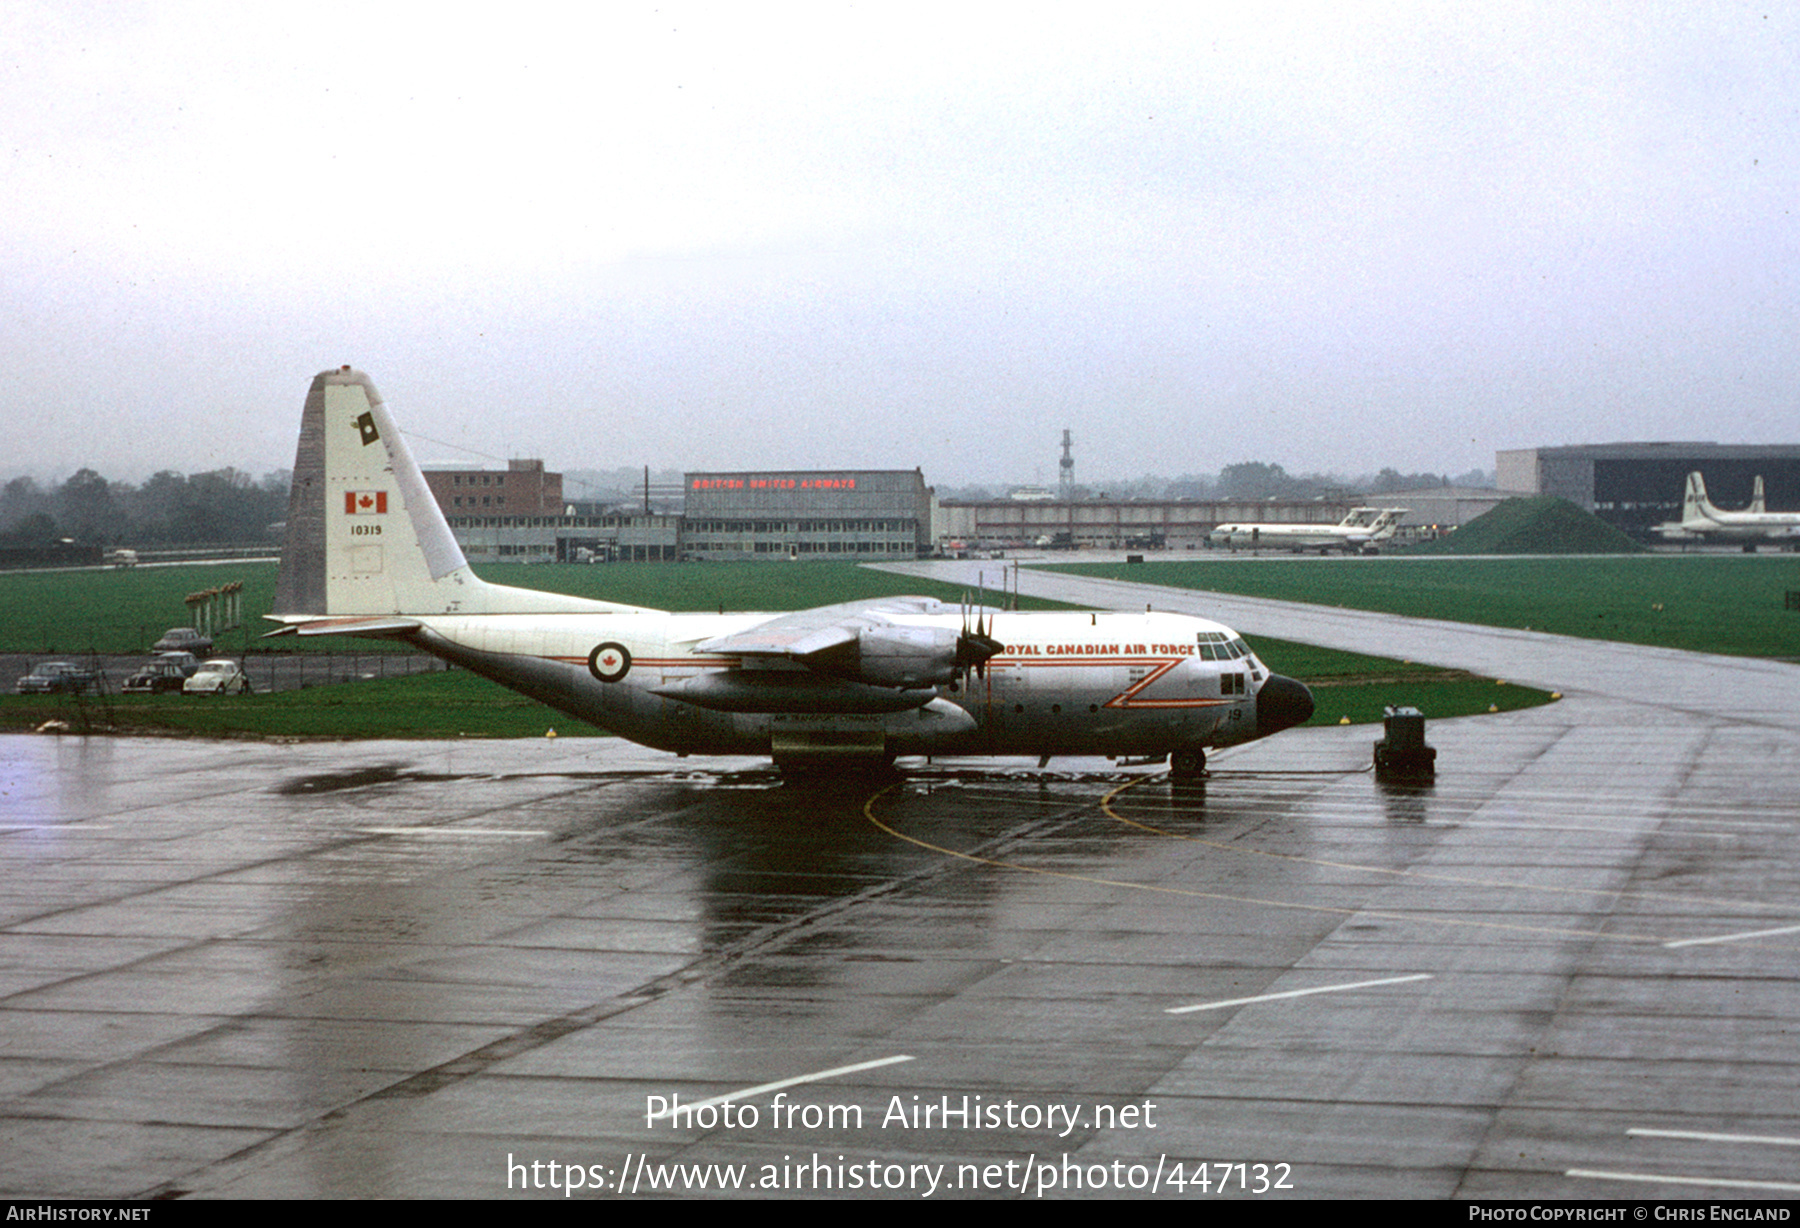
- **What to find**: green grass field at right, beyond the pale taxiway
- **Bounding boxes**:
[1067,555,1800,661]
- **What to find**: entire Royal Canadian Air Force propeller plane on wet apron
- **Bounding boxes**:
[270,367,1312,778]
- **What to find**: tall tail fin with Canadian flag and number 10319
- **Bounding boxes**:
[272,367,632,612]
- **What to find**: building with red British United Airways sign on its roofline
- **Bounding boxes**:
[682,468,932,562]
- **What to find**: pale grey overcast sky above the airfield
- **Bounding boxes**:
[0,0,1800,484]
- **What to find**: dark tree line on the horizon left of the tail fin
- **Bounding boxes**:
[0,468,292,547]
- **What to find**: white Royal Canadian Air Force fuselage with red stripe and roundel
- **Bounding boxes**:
[397,612,1310,754]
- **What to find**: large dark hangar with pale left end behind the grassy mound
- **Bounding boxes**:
[1494,443,1800,538]
